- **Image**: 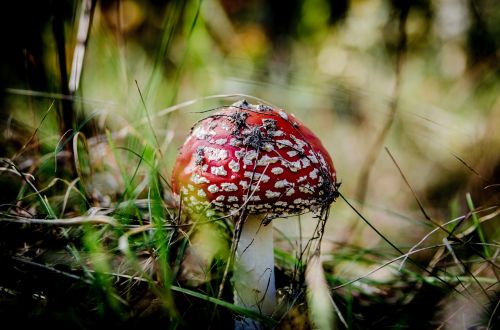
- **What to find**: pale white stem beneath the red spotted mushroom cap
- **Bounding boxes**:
[233,215,276,329]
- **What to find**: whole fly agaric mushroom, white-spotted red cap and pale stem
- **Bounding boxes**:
[172,100,338,328]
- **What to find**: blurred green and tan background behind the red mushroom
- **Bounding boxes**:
[0,0,500,328]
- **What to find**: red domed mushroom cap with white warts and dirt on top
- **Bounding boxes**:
[172,101,338,219]
